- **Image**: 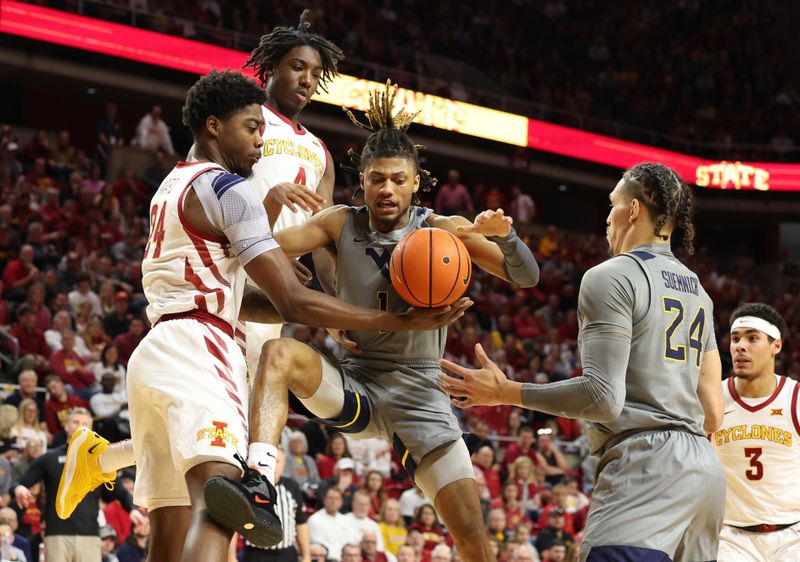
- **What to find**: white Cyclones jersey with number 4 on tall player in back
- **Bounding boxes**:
[250,104,327,232]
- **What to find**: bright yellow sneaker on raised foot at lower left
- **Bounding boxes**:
[56,427,117,519]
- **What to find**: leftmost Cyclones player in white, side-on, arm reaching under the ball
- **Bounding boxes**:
[57,72,464,562]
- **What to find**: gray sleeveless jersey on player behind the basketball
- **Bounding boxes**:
[336,207,440,365]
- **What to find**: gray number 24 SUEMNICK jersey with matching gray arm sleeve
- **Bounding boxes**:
[522,244,717,454]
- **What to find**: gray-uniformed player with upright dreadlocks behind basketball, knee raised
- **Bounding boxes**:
[208,83,539,562]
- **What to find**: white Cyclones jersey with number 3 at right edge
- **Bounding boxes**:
[711,375,800,527]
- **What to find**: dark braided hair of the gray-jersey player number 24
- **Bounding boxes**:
[622,162,694,254]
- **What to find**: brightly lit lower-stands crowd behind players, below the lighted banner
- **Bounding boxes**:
[0,96,800,562]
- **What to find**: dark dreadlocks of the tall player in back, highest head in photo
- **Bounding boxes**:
[243,10,344,92]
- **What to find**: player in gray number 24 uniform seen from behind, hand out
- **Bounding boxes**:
[439,163,725,562]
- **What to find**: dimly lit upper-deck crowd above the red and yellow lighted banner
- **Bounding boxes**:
[39,0,800,161]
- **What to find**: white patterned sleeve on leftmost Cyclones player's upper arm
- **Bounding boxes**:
[193,168,278,266]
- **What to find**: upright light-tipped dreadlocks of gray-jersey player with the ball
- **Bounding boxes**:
[342,80,439,197]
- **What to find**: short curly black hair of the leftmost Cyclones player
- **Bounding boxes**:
[183,70,267,138]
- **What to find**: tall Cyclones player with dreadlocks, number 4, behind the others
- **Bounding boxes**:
[236,10,344,377]
